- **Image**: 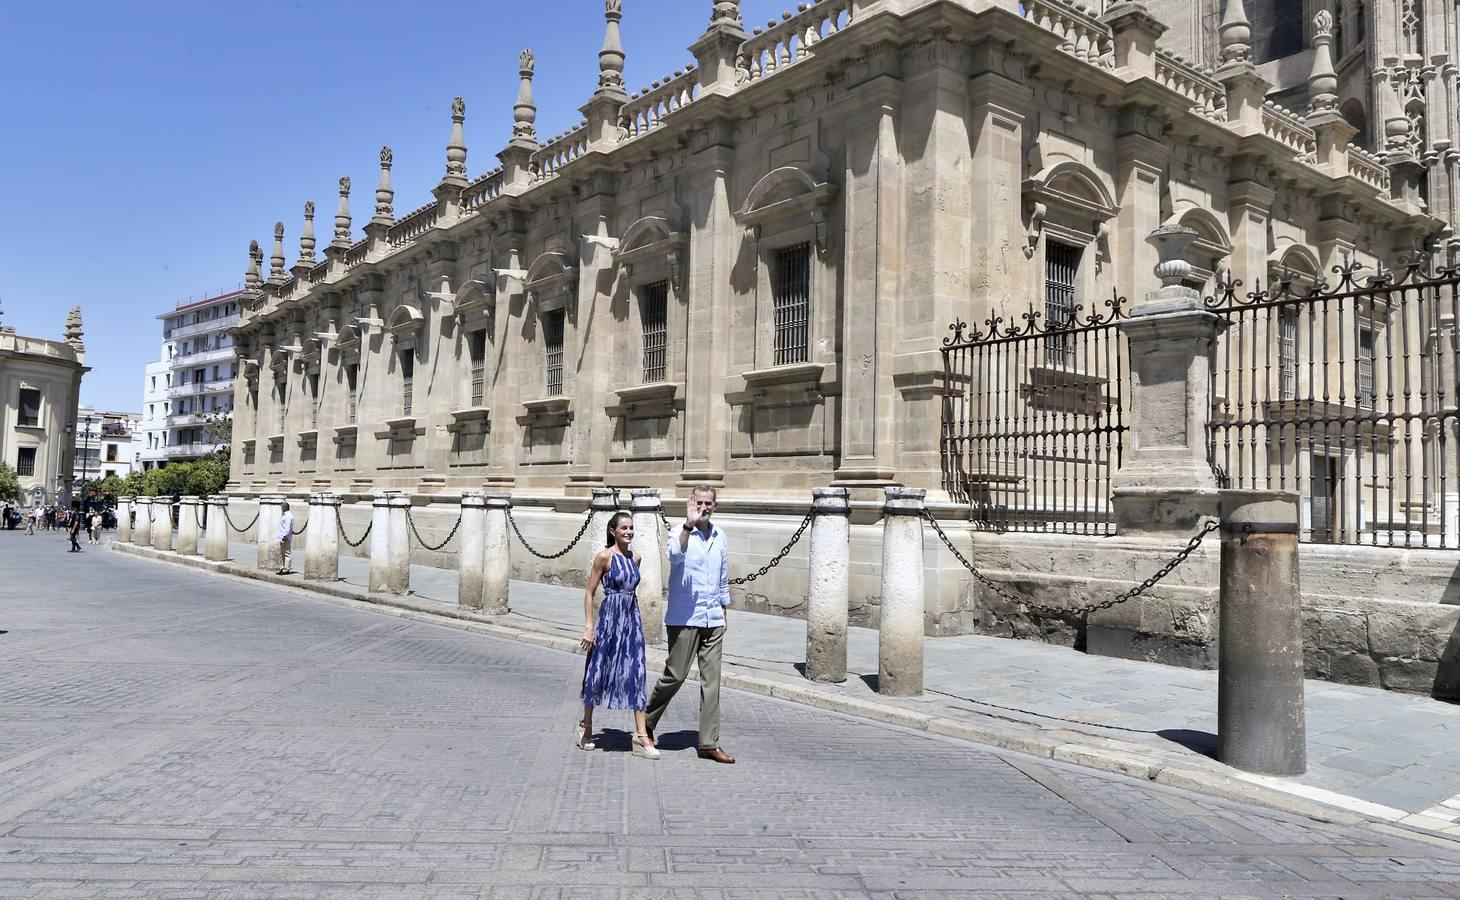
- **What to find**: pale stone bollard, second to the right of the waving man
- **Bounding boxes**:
[877,488,927,697]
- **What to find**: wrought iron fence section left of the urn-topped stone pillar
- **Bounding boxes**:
[940,295,1130,535]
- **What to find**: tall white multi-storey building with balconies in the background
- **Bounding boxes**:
[142,289,241,469]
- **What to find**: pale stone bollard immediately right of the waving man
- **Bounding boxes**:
[806,488,851,682]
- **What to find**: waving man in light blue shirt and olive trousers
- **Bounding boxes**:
[644,485,734,763]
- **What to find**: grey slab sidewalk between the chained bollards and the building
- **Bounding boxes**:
[156,542,1460,837]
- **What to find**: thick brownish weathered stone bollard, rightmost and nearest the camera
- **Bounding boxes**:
[1216,491,1308,774]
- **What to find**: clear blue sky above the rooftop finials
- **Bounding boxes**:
[0,0,794,412]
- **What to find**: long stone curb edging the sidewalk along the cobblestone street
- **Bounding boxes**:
[107,542,1460,847]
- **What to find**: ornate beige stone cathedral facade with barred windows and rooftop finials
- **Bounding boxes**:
[231,0,1436,508]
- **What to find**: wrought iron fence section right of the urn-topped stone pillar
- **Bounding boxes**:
[1205,257,1460,549]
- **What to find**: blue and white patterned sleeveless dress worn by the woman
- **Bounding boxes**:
[583,551,648,710]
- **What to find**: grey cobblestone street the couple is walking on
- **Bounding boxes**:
[8,533,1460,899]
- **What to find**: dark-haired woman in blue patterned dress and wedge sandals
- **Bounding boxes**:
[577,513,660,760]
